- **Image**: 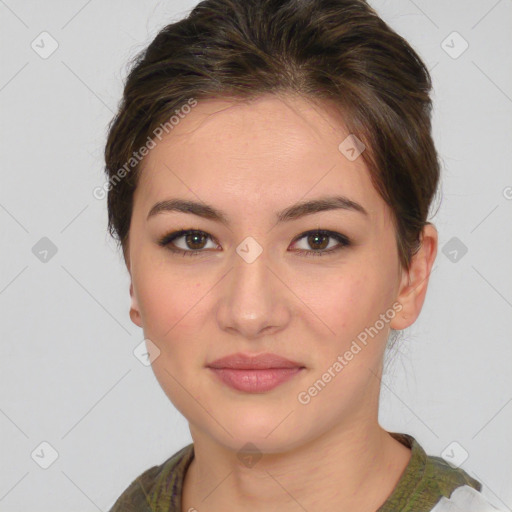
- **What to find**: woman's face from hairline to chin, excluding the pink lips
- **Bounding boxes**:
[128,95,412,452]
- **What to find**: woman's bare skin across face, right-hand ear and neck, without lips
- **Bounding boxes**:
[127,95,437,512]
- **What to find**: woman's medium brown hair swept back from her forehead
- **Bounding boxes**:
[105,0,440,269]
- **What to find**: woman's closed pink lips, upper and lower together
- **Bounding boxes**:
[207,353,304,393]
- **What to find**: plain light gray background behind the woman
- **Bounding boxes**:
[0,0,512,512]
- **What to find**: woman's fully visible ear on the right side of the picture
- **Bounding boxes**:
[390,223,438,330]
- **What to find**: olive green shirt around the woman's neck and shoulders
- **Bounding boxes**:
[109,432,482,512]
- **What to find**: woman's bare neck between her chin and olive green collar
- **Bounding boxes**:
[182,418,411,512]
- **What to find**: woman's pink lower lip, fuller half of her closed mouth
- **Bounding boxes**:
[210,368,303,393]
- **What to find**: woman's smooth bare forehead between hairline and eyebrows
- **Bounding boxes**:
[135,95,386,224]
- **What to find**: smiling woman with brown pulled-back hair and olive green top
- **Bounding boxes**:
[105,0,504,512]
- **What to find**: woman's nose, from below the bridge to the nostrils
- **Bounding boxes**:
[217,247,292,340]
